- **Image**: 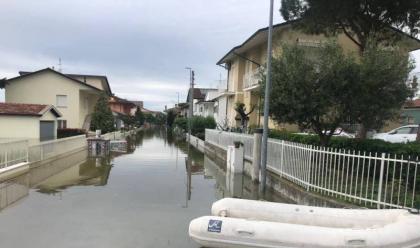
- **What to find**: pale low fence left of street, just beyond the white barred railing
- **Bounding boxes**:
[28,135,87,162]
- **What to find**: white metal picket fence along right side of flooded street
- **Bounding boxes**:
[206,130,420,208]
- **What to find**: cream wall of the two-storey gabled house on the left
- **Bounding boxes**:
[5,71,98,128]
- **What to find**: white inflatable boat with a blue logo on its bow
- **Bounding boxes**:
[189,198,420,248]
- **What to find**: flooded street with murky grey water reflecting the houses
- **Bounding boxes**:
[0,131,290,248]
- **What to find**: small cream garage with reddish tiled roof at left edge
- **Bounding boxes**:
[0,103,61,141]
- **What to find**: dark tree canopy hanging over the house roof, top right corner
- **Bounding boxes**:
[280,0,420,51]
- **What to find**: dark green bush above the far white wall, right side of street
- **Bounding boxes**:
[174,116,216,140]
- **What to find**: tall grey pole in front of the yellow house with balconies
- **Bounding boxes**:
[261,0,274,191]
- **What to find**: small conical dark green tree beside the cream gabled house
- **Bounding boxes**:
[90,94,115,133]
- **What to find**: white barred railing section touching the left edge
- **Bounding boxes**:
[0,140,28,169]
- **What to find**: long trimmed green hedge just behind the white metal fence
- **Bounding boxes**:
[269,130,420,156]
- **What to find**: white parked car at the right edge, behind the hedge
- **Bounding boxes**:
[373,125,419,143]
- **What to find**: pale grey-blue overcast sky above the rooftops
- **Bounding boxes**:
[0,0,420,110]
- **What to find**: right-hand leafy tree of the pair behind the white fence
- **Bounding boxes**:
[352,45,415,138]
